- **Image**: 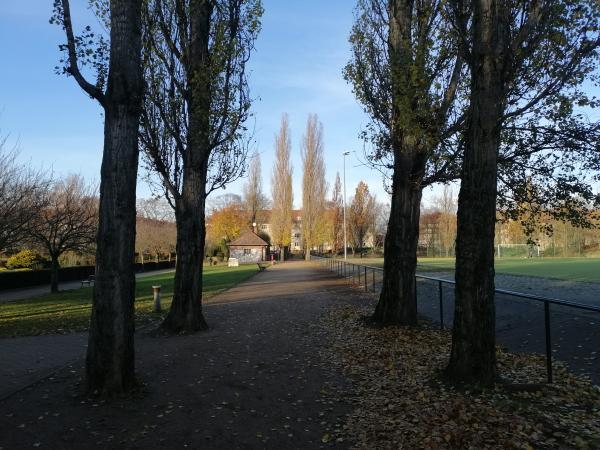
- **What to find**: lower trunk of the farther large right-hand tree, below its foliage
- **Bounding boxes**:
[373,151,425,325]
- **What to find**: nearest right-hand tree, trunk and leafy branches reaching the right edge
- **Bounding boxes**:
[446,0,600,385]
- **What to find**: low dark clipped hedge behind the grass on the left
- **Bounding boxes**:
[0,260,175,291]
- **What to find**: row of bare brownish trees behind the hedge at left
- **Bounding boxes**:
[0,146,175,292]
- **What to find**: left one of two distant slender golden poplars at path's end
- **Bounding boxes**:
[271,114,293,261]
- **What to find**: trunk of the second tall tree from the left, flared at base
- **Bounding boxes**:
[161,0,213,333]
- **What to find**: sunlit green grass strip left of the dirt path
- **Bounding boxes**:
[0,264,258,337]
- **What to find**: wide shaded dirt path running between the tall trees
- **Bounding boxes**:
[0,262,361,449]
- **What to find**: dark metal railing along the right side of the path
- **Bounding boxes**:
[311,255,600,383]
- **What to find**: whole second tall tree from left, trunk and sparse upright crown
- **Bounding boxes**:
[141,0,262,333]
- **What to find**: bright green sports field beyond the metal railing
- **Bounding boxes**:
[338,258,600,283]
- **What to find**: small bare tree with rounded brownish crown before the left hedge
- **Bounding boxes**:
[26,175,98,292]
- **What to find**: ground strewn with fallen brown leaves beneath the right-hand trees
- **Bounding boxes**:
[321,307,600,449]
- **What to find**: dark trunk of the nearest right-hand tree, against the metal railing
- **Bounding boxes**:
[447,0,509,385]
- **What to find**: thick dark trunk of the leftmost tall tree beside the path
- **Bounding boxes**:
[86,0,142,395]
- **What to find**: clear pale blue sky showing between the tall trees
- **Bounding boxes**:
[0,0,418,206]
